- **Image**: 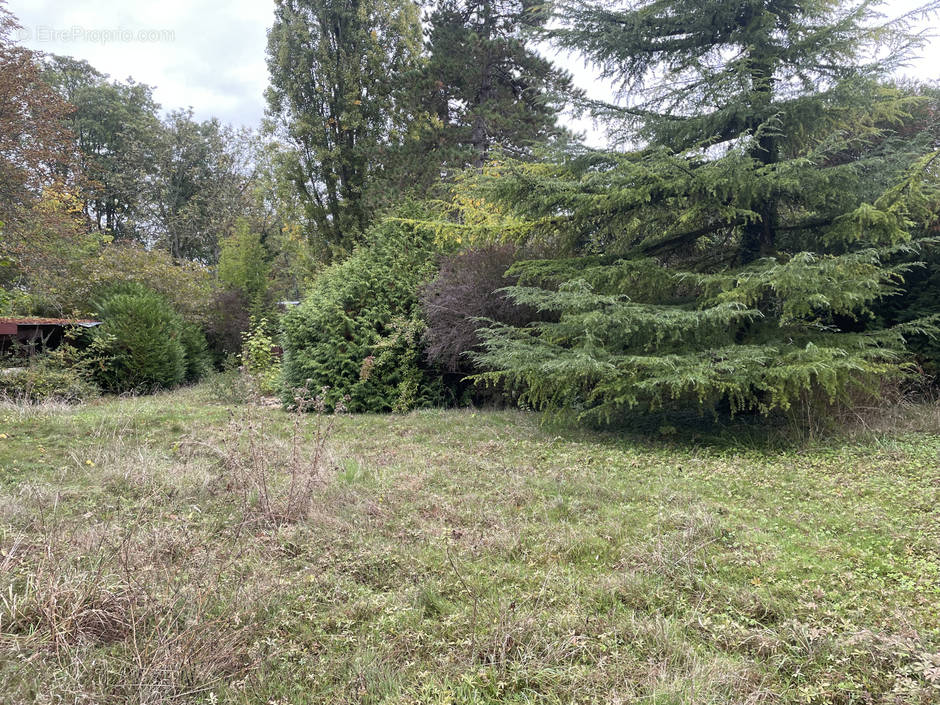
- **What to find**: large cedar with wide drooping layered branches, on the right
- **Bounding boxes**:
[434,0,938,419]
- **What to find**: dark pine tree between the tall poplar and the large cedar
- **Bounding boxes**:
[427,0,572,168]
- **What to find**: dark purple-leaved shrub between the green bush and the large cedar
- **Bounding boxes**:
[420,245,536,374]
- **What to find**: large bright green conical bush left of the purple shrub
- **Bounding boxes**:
[283,222,443,412]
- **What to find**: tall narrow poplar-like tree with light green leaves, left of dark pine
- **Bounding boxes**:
[267,0,421,253]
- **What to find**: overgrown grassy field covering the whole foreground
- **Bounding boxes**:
[0,388,940,705]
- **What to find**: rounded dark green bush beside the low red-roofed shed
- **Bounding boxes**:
[95,284,205,392]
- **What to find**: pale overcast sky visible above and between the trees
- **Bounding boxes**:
[8,0,940,143]
